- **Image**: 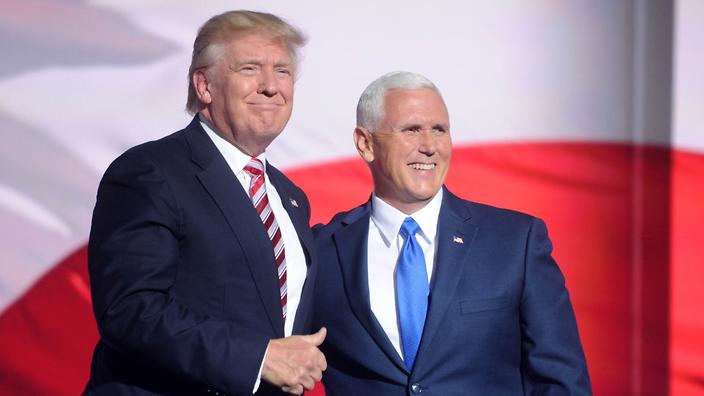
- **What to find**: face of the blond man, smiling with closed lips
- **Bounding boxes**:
[193,34,294,156]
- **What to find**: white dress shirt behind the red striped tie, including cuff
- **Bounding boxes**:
[200,119,308,392]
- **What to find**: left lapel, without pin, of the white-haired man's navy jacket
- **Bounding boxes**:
[333,202,408,372]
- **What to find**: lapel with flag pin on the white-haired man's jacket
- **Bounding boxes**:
[414,189,478,370]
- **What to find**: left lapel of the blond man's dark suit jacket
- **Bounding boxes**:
[186,117,284,338]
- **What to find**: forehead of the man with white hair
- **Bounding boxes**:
[384,88,449,124]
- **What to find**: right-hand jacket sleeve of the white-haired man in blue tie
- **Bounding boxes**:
[520,218,592,395]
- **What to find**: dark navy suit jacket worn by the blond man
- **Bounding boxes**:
[86,117,316,395]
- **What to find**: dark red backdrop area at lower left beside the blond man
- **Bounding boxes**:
[0,248,98,395]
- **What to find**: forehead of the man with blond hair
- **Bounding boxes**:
[225,32,291,63]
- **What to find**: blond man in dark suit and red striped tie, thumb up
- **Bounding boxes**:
[85,11,326,395]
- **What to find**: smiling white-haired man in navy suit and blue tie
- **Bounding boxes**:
[314,72,591,396]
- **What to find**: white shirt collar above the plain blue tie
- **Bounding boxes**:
[371,188,443,246]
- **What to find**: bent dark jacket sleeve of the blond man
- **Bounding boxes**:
[88,150,269,394]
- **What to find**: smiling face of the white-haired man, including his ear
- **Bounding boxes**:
[355,89,452,214]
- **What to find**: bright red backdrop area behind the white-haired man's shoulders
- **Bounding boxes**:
[287,143,704,396]
